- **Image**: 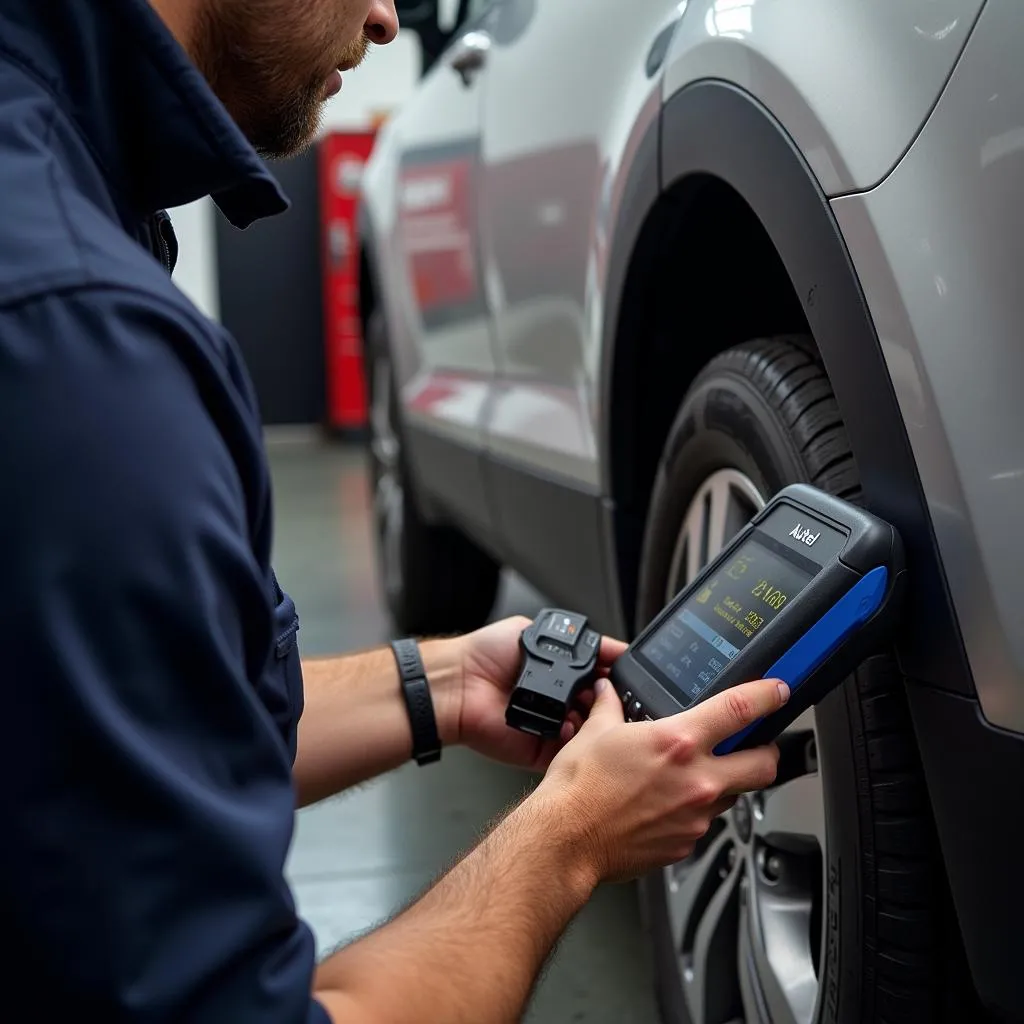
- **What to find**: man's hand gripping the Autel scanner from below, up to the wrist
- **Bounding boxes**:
[526,680,788,881]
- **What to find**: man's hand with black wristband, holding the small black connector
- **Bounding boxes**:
[458,616,627,771]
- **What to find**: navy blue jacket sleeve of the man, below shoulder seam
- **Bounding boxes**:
[0,290,327,1024]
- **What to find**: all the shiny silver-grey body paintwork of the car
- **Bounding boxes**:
[364,0,1024,730]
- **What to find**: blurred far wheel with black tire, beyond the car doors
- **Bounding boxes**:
[366,309,501,636]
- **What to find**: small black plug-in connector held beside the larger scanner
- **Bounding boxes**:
[505,608,601,739]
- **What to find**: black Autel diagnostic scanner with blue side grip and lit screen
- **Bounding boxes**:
[611,484,906,754]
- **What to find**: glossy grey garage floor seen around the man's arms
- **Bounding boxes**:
[270,437,656,1024]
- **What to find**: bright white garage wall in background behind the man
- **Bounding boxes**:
[170,32,421,319]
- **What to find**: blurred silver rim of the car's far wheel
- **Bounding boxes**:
[370,355,406,604]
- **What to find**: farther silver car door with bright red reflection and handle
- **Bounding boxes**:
[383,0,497,531]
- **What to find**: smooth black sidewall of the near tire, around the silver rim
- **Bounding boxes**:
[636,368,862,1024]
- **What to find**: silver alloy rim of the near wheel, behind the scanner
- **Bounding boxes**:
[666,469,825,1024]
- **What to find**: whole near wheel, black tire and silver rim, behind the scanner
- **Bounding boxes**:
[638,338,944,1024]
